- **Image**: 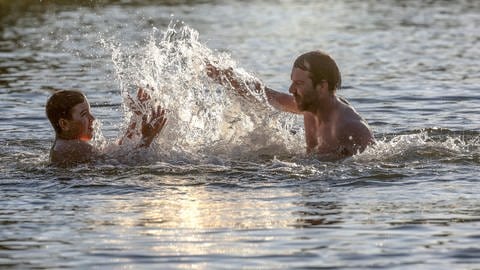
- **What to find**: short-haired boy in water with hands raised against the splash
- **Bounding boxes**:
[46,88,166,166]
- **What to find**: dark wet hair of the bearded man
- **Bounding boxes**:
[293,51,342,93]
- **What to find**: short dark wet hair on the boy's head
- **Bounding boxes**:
[45,90,86,134]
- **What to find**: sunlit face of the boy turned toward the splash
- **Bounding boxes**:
[61,100,95,141]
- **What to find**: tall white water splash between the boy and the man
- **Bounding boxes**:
[103,22,304,162]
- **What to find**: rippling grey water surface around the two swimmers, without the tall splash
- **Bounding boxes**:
[0,0,480,269]
